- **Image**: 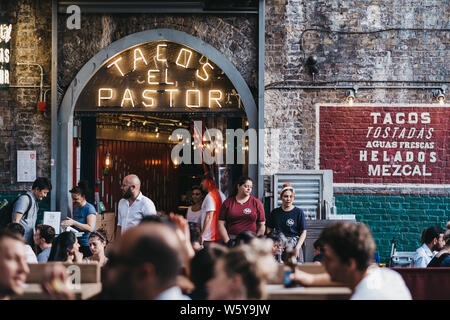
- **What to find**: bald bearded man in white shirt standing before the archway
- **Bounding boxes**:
[116,174,156,237]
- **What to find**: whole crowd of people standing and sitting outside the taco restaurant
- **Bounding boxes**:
[0,175,450,300]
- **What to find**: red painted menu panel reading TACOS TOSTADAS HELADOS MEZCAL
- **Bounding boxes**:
[319,106,450,184]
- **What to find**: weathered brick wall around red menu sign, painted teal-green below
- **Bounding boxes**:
[264,0,450,261]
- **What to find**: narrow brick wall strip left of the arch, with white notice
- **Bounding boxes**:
[0,0,51,190]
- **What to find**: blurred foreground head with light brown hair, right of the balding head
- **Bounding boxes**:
[207,239,278,300]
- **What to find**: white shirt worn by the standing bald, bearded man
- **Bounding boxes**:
[117,192,156,233]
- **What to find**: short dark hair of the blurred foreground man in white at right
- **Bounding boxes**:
[319,222,376,271]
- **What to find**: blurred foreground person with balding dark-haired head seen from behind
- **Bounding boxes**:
[100,222,189,300]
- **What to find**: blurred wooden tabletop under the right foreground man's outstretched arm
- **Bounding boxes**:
[266,284,351,300]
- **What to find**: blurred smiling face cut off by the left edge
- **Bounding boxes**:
[0,230,30,300]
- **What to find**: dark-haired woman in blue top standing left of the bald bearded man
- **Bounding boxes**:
[61,181,97,258]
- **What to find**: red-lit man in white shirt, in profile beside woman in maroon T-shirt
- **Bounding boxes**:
[200,175,226,244]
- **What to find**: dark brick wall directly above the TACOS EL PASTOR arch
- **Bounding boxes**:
[58,12,258,97]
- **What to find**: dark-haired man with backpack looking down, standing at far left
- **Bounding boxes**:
[12,178,52,245]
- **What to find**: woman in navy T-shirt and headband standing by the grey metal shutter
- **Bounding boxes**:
[267,183,306,262]
